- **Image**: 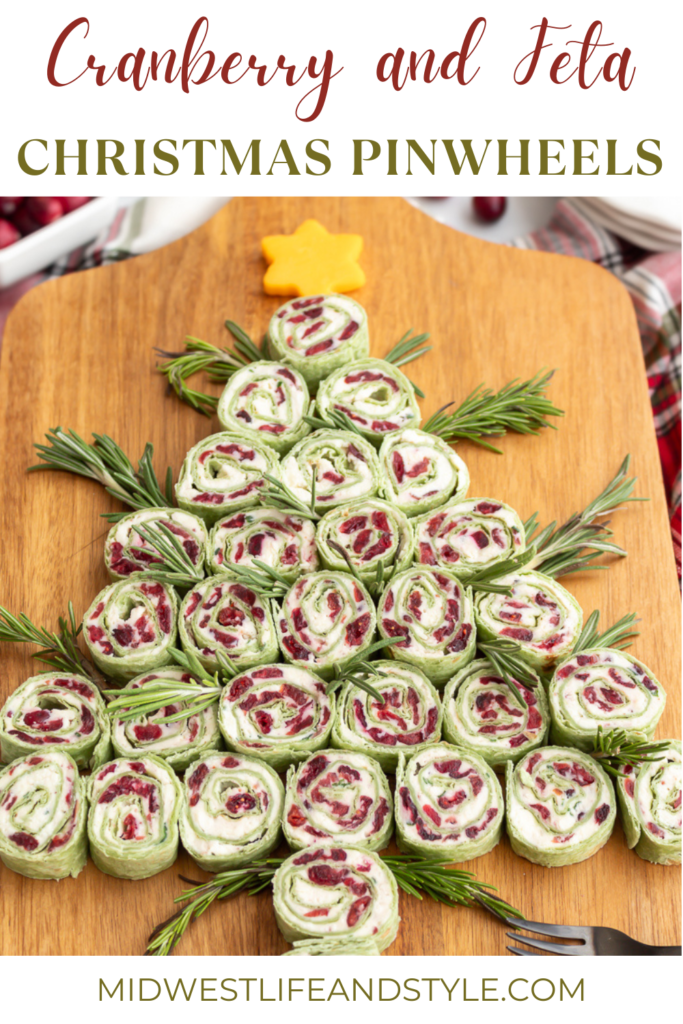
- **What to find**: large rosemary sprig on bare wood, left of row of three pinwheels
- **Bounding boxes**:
[29,427,173,522]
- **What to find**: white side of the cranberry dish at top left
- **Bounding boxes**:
[0,196,119,288]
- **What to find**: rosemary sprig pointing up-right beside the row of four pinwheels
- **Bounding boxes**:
[524,455,649,579]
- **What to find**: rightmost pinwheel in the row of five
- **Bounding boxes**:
[474,570,584,672]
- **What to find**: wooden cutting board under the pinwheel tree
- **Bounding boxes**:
[0,199,681,955]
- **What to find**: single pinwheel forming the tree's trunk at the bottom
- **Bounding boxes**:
[272,844,400,951]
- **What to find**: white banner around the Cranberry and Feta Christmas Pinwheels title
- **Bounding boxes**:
[0,0,681,196]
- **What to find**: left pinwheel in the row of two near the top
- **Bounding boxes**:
[216,360,310,454]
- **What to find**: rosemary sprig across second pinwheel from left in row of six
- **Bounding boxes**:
[104,650,227,722]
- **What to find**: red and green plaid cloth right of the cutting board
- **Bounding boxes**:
[512,200,681,580]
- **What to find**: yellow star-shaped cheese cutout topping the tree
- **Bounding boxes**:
[261,220,366,295]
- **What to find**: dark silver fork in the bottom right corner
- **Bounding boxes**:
[501,914,681,956]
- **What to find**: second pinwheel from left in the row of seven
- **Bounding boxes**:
[87,754,182,879]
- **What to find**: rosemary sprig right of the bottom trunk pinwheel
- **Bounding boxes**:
[382,854,523,919]
